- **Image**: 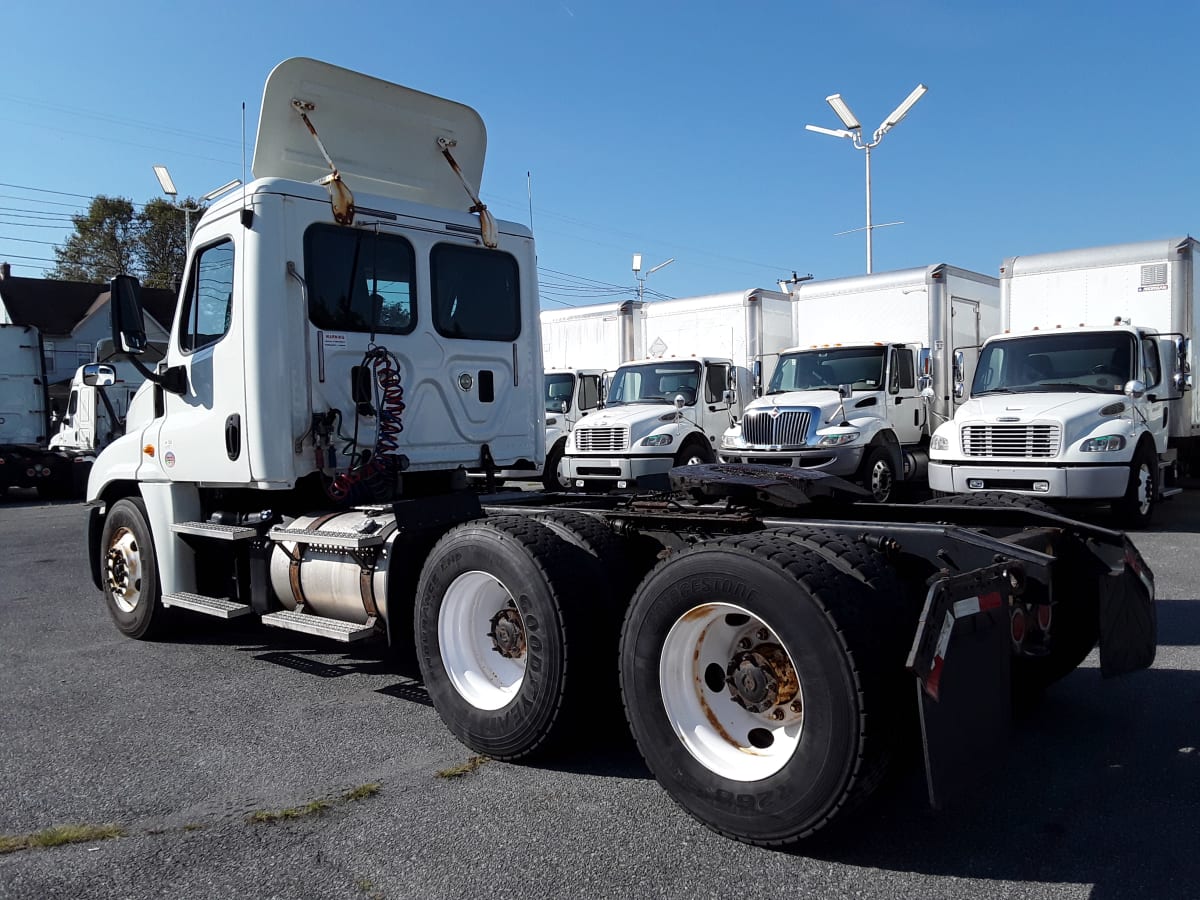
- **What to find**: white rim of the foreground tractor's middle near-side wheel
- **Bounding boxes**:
[438,571,526,709]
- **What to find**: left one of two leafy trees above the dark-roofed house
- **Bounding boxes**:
[46,197,140,282]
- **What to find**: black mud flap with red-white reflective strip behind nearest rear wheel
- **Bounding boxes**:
[907,563,1025,809]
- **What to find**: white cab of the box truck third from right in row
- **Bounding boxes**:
[562,356,750,490]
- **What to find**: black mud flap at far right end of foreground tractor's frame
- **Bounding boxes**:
[1100,538,1158,678]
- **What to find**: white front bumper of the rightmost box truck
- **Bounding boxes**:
[929,460,1129,500]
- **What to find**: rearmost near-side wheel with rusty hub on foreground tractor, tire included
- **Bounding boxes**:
[620,533,907,846]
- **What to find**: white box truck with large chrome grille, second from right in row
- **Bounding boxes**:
[720,264,1000,503]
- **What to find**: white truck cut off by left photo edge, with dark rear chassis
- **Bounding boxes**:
[0,324,92,499]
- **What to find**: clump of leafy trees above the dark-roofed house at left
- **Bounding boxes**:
[46,196,200,288]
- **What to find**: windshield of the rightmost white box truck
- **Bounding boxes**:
[971,331,1134,397]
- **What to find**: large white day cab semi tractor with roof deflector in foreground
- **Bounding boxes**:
[85,59,1156,846]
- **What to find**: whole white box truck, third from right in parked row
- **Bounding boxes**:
[562,288,792,490]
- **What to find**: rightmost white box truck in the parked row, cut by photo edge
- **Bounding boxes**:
[929,238,1200,527]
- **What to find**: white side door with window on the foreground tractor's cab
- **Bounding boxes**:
[152,238,250,484]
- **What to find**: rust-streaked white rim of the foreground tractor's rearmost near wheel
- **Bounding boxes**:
[659,604,804,781]
